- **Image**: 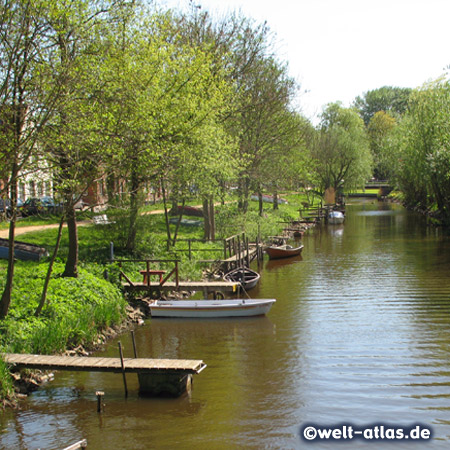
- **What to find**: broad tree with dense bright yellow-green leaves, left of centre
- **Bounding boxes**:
[103,9,236,252]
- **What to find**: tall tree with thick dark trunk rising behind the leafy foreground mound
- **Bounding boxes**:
[41,0,128,277]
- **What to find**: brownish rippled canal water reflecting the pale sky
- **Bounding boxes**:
[0,201,450,450]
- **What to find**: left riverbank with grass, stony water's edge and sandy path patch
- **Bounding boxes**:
[0,195,316,406]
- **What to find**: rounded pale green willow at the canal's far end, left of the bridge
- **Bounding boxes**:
[310,103,372,202]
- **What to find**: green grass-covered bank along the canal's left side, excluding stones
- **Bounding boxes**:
[0,194,314,399]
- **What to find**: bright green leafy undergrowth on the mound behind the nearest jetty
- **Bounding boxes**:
[0,263,125,354]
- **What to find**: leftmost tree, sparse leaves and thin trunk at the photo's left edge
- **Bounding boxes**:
[0,0,63,318]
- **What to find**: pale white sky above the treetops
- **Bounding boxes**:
[161,0,450,122]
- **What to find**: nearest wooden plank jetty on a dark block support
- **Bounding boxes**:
[2,353,206,396]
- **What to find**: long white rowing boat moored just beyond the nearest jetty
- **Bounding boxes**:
[149,298,276,318]
